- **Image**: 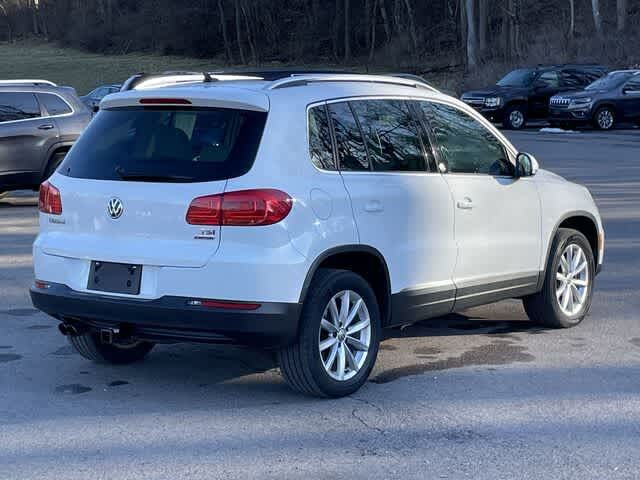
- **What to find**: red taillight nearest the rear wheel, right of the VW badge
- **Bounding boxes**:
[187,189,292,227]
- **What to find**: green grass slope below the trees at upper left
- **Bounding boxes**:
[0,41,220,95]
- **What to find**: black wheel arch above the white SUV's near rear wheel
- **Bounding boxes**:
[300,245,391,327]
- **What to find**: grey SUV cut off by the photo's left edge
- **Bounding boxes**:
[0,80,91,194]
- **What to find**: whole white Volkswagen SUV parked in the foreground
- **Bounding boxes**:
[31,74,604,397]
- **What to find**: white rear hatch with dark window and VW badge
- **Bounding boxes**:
[40,99,267,267]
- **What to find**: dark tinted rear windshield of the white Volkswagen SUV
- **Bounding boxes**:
[58,107,267,182]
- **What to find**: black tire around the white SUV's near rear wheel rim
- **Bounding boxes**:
[278,269,381,397]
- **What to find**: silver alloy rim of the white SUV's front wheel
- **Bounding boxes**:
[556,243,590,316]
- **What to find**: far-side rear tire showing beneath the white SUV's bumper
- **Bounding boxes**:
[67,333,154,365]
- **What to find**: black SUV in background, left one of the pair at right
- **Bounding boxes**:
[461,65,606,130]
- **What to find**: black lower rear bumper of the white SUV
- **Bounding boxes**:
[30,284,301,348]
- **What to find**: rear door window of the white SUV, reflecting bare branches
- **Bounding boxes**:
[351,100,427,172]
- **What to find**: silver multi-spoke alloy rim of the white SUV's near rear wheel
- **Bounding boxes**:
[318,290,371,381]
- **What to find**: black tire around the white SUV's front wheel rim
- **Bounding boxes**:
[522,228,595,328]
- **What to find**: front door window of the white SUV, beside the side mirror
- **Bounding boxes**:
[420,102,514,176]
